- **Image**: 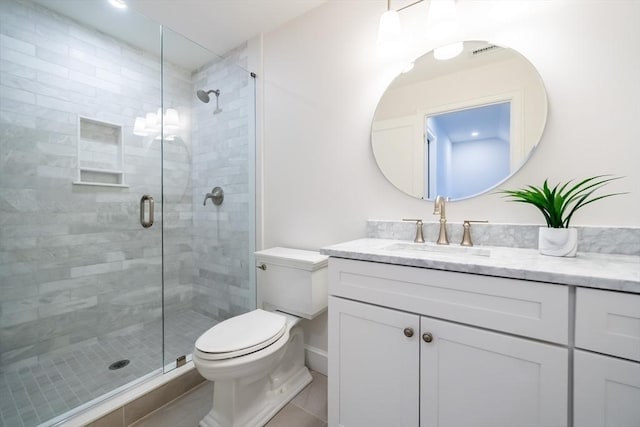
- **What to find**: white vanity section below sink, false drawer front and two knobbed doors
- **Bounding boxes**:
[329,258,569,427]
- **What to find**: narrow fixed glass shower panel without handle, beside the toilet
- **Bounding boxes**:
[162,28,256,369]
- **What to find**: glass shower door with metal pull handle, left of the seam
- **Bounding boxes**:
[0,0,163,427]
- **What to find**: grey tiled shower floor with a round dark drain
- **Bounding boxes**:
[0,310,216,427]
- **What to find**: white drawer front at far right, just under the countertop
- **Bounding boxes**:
[576,288,640,361]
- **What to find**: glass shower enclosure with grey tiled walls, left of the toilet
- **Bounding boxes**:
[0,0,256,427]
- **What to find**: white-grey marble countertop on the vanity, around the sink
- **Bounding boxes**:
[320,239,640,294]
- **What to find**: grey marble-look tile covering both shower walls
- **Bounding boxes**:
[0,0,255,372]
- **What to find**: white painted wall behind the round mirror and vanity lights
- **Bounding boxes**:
[263,0,640,254]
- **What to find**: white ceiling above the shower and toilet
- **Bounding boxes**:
[32,0,327,70]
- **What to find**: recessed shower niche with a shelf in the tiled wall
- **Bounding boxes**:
[74,116,128,187]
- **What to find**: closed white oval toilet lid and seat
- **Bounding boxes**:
[196,309,287,360]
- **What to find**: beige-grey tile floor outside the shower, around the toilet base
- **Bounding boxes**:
[131,371,327,427]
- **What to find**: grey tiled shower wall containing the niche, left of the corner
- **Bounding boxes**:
[0,0,195,366]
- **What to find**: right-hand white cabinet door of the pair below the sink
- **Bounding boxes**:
[420,317,568,427]
